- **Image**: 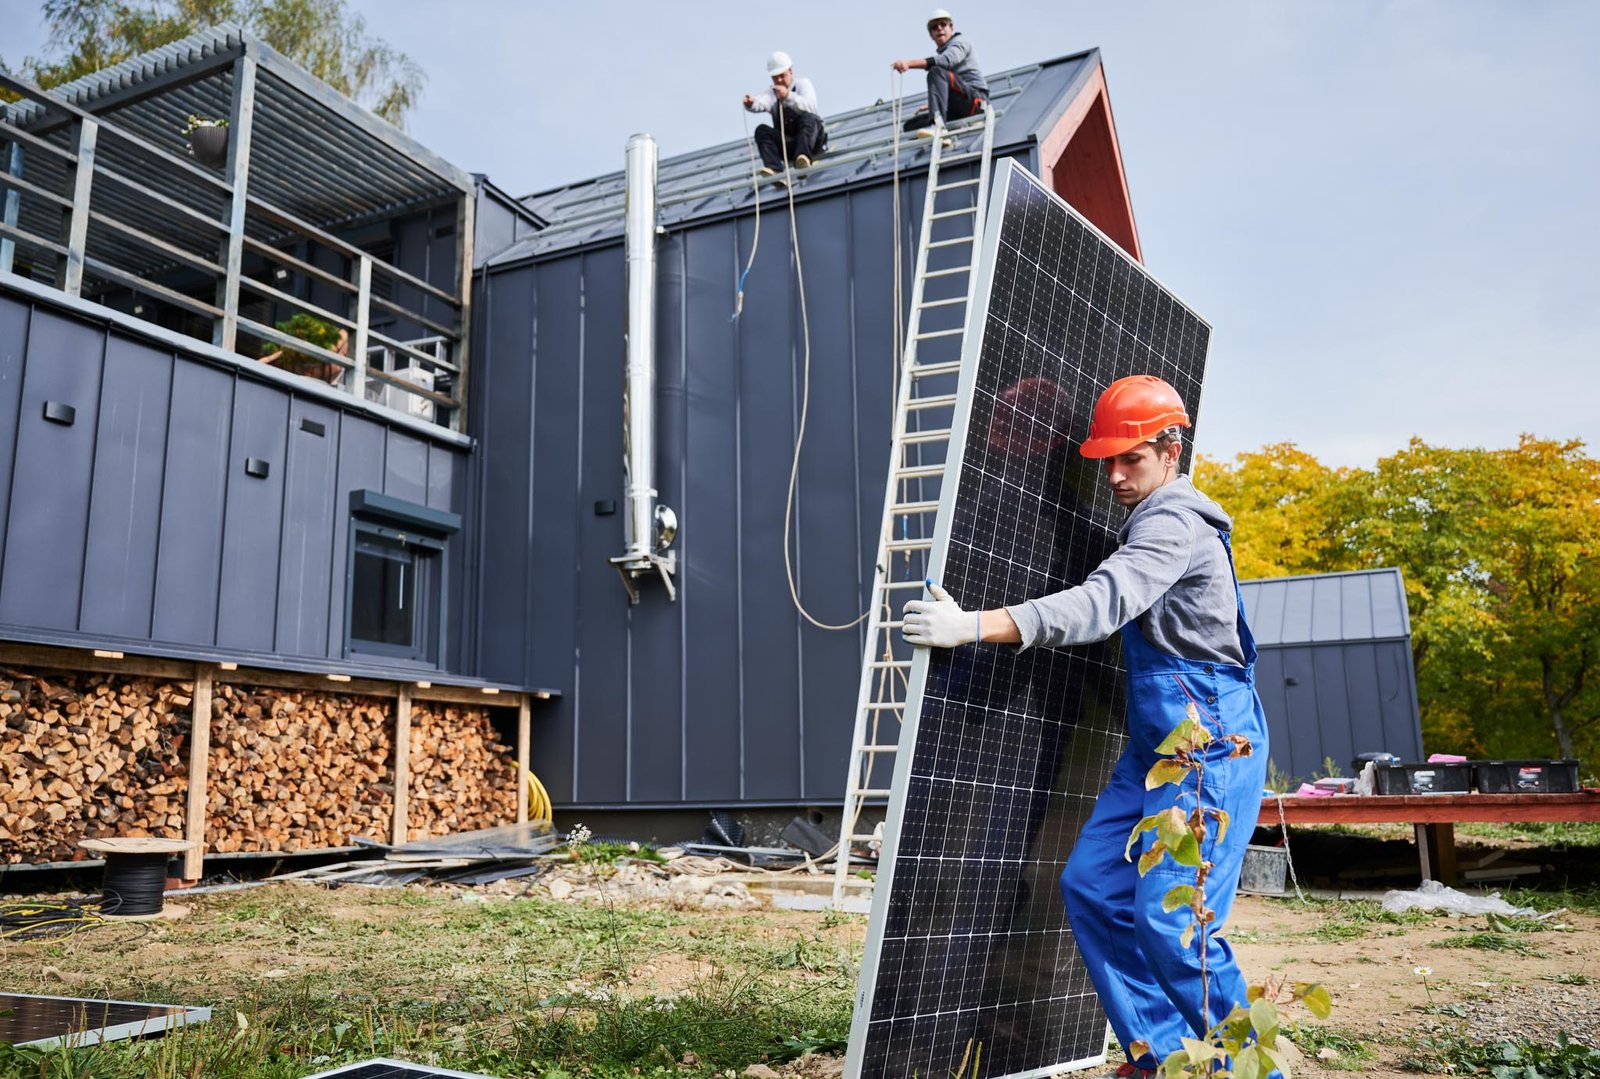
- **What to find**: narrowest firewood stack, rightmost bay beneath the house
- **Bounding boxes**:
[406,701,520,839]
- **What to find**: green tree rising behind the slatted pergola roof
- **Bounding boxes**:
[10,0,424,125]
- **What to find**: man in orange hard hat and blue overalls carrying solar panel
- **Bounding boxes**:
[902,375,1267,1076]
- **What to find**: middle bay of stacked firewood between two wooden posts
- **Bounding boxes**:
[206,685,394,852]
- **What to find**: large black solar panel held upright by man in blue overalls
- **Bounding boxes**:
[846,160,1210,1079]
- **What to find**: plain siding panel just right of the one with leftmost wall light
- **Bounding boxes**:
[78,338,173,637]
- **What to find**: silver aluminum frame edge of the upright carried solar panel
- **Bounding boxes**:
[845,158,1210,1079]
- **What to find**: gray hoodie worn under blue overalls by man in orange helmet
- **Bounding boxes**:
[1006,475,1245,666]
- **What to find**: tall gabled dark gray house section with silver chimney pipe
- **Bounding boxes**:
[469,51,1139,808]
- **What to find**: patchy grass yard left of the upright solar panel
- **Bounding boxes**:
[0,885,859,1079]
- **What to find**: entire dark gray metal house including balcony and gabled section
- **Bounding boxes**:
[0,27,1139,808]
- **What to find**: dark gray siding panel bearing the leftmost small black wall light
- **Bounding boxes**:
[0,311,106,631]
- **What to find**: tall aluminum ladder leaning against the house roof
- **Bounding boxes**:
[834,109,1000,909]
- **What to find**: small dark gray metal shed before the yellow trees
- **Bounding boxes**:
[1238,568,1422,780]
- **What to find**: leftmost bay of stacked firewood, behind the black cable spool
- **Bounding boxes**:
[0,669,194,863]
